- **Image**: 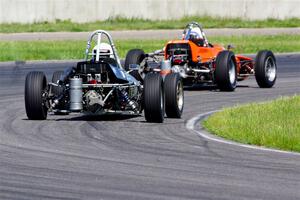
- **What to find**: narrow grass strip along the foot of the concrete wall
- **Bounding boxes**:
[0,16,300,33]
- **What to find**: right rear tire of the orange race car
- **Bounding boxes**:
[215,50,237,91]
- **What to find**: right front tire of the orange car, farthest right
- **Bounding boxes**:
[254,50,277,88]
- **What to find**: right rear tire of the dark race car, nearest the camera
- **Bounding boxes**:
[143,73,165,123]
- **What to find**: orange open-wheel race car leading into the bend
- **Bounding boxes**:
[125,22,277,91]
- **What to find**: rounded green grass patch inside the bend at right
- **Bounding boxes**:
[203,96,300,152]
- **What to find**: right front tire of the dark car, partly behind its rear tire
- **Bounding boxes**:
[164,73,184,118]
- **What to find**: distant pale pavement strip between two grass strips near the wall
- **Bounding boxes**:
[0,27,300,41]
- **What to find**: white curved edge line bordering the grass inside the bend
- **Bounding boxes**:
[185,110,300,156]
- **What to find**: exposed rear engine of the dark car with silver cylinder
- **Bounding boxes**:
[69,60,141,114]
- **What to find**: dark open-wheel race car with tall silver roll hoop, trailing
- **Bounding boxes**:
[25,30,183,122]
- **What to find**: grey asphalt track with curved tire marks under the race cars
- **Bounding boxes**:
[0,55,300,200]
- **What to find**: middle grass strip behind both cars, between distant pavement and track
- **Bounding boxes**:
[0,35,300,61]
